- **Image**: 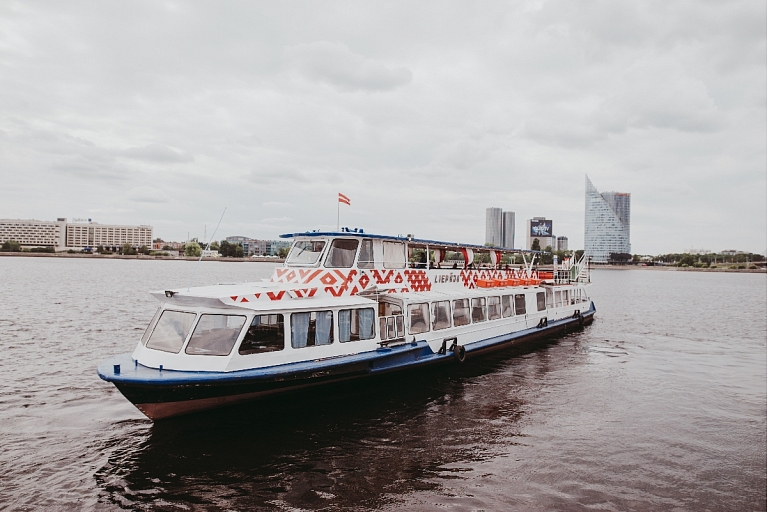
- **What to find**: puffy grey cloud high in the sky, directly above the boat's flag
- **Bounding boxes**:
[285,41,413,91]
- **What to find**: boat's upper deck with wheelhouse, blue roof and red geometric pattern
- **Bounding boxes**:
[155,230,588,309]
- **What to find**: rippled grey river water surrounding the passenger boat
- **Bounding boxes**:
[0,257,767,511]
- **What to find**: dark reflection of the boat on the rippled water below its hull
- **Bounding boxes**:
[96,337,572,510]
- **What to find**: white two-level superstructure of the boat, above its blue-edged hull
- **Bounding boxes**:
[133,230,588,371]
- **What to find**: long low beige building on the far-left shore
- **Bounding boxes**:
[0,218,152,251]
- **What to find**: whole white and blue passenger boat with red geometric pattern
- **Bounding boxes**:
[98,228,595,420]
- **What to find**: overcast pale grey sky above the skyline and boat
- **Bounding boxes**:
[0,0,766,254]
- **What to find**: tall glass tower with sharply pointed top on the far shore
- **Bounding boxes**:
[584,176,632,263]
